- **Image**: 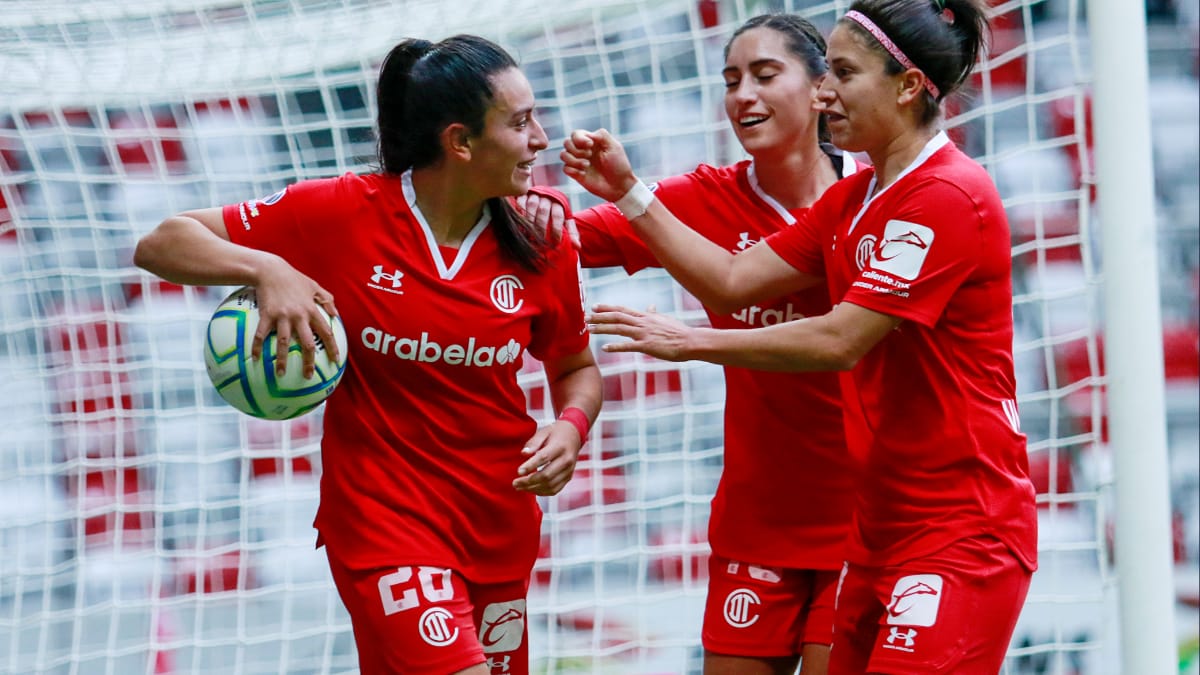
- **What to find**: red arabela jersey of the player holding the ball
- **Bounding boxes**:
[223,173,588,583]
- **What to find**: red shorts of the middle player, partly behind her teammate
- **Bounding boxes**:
[701,554,838,657]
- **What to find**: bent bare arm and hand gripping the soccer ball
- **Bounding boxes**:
[133,208,340,377]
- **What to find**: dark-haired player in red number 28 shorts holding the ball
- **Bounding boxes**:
[134,35,601,675]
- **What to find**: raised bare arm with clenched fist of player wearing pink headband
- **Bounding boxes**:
[560,129,820,313]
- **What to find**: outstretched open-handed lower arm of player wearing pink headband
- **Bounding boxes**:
[588,303,901,371]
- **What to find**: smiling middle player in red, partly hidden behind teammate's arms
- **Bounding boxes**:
[526,13,860,675]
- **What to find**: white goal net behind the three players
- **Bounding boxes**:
[0,0,1180,674]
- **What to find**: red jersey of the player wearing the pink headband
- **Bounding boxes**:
[767,133,1037,571]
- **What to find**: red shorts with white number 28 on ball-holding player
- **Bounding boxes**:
[329,558,529,675]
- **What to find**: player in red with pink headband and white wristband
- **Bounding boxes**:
[562,0,1037,675]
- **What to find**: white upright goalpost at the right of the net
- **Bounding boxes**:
[1087,0,1178,675]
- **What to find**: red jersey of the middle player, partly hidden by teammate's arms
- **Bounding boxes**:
[575,157,858,569]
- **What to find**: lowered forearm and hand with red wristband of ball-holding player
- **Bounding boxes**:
[512,341,601,496]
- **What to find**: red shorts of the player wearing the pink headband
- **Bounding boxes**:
[829,537,1032,675]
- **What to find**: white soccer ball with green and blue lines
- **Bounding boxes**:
[204,286,348,419]
